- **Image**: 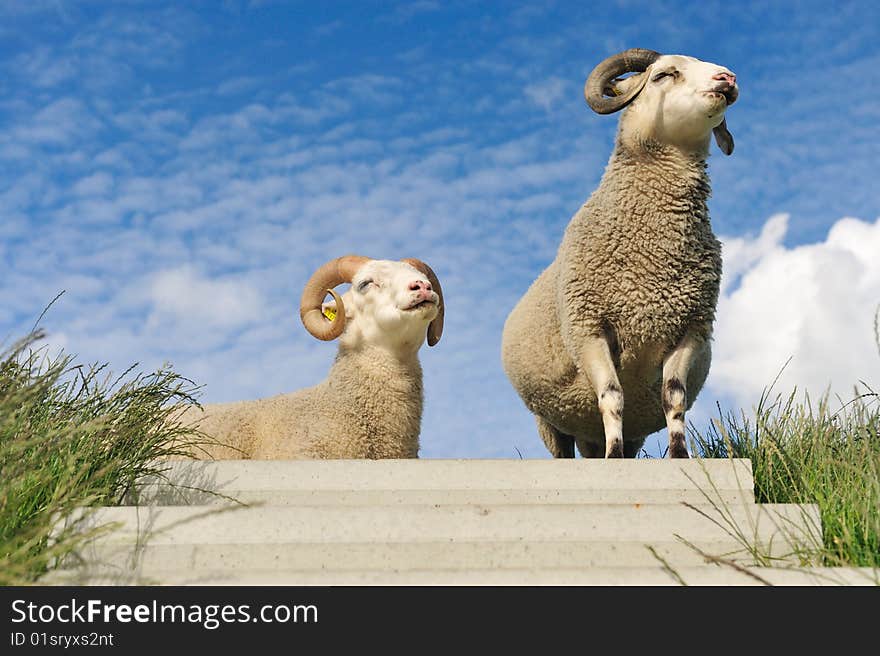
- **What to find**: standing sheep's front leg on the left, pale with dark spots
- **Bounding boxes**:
[581,337,623,458]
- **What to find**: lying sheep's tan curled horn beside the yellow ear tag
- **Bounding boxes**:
[299,255,370,341]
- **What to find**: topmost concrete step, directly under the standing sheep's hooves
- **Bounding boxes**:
[132,459,754,505]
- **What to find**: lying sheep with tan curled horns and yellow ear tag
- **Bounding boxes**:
[189,255,444,459]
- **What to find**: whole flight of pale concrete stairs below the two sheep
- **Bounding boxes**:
[45,459,876,585]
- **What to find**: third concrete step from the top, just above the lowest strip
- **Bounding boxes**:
[58,540,804,576]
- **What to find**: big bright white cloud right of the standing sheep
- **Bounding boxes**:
[701,215,880,408]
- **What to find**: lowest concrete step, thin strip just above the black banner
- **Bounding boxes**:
[44,565,880,586]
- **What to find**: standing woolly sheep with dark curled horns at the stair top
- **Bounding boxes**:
[502,48,739,458]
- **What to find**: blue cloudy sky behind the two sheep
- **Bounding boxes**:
[0,0,880,458]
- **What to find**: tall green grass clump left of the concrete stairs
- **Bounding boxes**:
[0,331,205,585]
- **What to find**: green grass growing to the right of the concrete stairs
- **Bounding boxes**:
[691,386,880,568]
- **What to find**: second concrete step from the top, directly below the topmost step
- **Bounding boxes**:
[60,504,821,548]
